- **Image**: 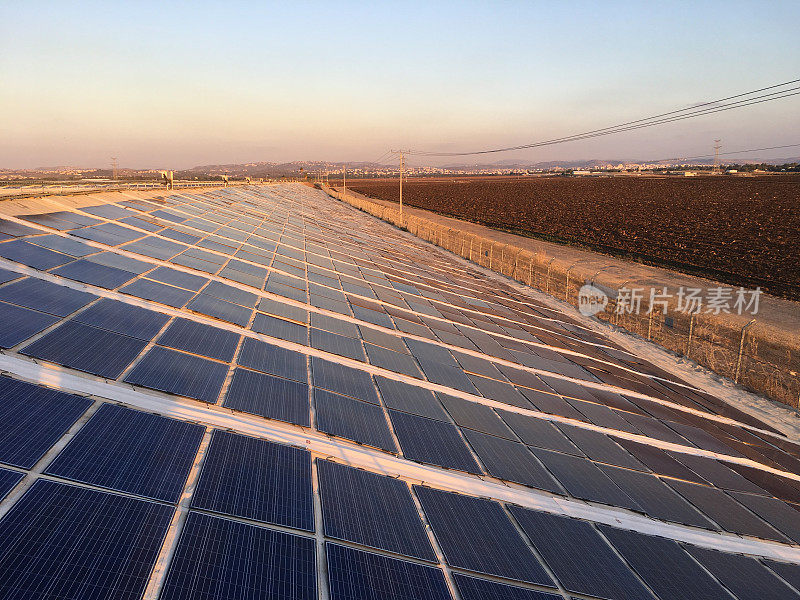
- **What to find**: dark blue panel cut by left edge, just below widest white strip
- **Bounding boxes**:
[0,376,92,469]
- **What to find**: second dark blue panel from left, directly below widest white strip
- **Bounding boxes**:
[47,404,205,502]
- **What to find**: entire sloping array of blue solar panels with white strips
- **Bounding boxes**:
[0,185,800,600]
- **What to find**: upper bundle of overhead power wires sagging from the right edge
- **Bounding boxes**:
[410,79,800,156]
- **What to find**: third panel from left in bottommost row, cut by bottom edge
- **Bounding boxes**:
[325,542,451,600]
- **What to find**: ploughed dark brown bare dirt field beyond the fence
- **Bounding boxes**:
[347,175,800,300]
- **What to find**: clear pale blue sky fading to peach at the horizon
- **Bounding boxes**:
[0,0,800,169]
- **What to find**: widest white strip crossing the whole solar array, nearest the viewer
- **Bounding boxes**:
[0,355,800,563]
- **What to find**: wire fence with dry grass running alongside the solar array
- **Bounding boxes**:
[326,189,800,409]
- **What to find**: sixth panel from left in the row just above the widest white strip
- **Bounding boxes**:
[389,410,481,473]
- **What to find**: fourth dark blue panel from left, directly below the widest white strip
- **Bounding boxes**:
[317,460,437,562]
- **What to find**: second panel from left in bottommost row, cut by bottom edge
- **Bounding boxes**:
[159,511,317,600]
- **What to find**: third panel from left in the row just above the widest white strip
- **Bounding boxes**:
[125,346,228,404]
